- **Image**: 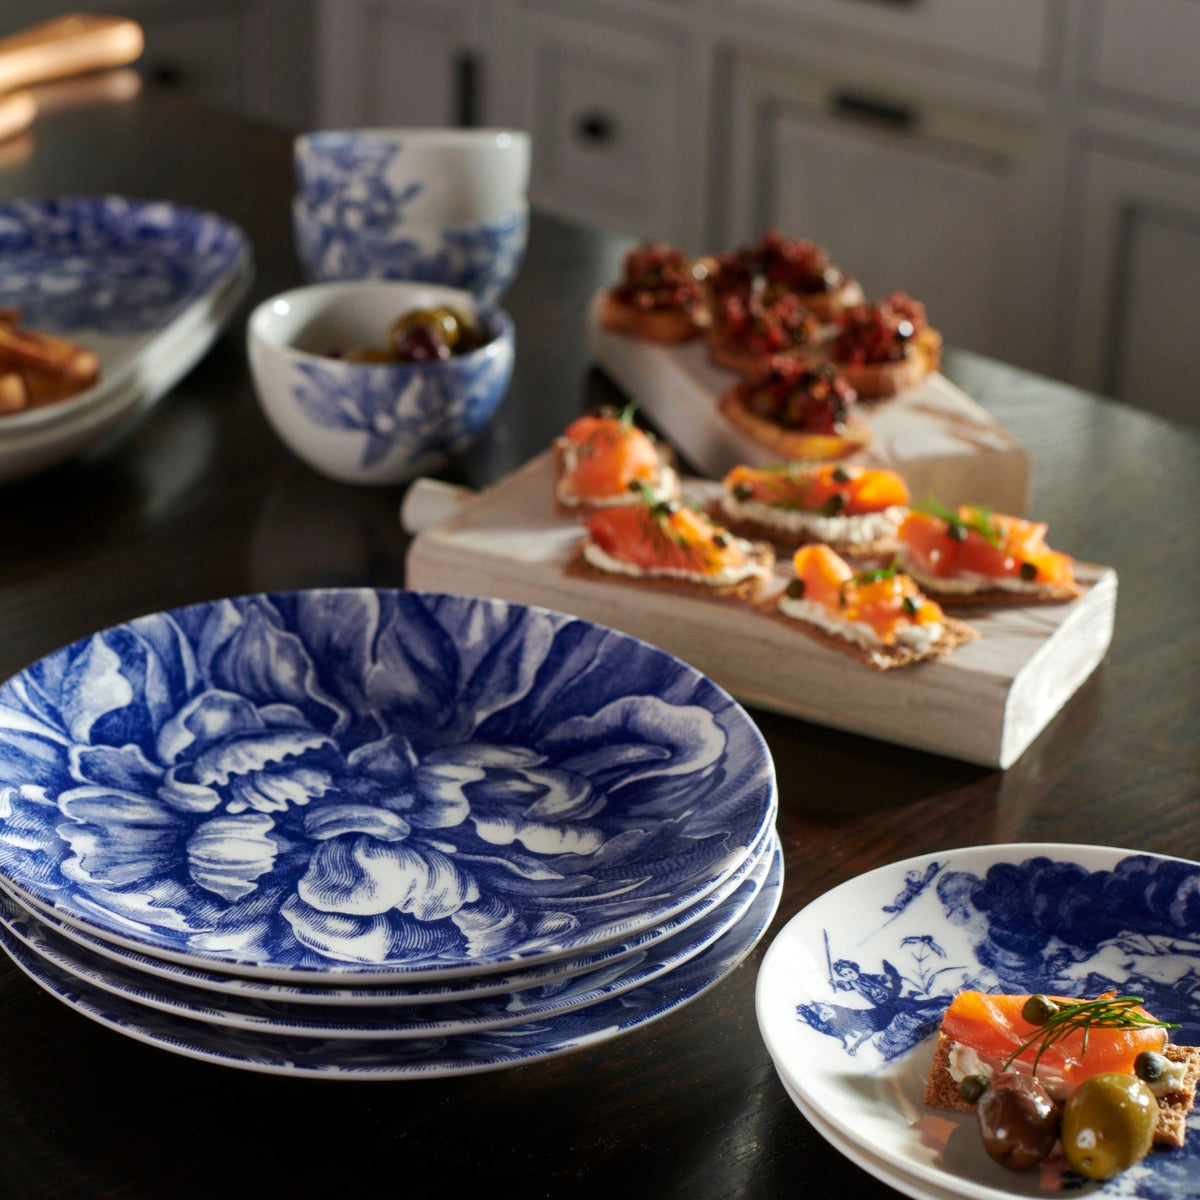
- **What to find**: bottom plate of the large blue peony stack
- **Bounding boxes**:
[0,848,784,1080]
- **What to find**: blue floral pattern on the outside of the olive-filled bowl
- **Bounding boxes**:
[292,308,512,467]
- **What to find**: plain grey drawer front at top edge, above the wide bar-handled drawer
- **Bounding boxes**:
[738,0,1054,71]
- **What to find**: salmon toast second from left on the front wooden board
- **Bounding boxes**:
[568,489,775,601]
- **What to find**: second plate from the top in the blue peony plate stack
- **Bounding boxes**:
[0,827,775,1008]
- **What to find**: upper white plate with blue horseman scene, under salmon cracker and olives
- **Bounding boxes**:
[756,845,1200,1200]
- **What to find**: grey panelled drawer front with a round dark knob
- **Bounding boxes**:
[511,10,685,236]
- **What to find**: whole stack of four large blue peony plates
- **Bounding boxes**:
[0,589,782,1079]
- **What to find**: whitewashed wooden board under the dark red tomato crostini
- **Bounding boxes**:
[588,296,1030,515]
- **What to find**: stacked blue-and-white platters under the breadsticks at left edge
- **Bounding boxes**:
[0,196,254,482]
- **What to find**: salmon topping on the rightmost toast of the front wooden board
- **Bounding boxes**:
[899,504,1074,584]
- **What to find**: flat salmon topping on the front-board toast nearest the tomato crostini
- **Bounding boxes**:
[725,464,908,516]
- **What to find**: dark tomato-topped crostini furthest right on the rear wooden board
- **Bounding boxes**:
[829,292,942,400]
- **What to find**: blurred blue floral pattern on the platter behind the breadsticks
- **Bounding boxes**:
[0,196,250,336]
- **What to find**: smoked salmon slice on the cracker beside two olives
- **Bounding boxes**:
[942,991,1166,1084]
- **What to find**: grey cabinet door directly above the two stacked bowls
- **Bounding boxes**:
[318,0,482,127]
